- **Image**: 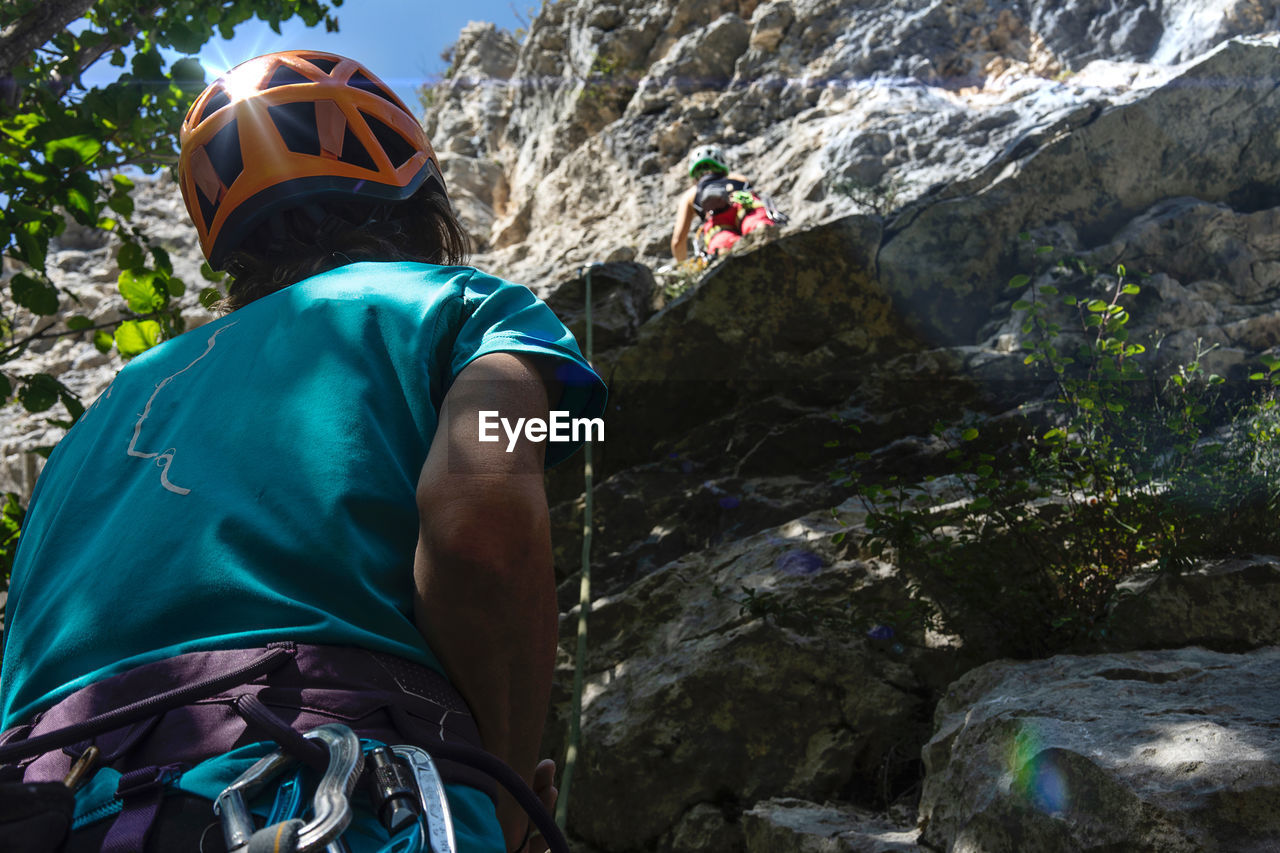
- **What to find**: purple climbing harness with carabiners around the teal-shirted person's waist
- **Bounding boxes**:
[0,643,568,853]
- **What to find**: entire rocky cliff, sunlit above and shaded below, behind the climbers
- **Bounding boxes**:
[5,0,1280,853]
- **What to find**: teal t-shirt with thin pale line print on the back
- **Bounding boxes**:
[0,263,605,845]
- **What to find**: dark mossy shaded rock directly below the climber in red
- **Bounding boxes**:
[605,216,910,470]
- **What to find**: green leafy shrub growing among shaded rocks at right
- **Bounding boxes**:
[833,242,1280,656]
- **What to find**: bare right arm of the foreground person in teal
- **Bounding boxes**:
[413,352,557,849]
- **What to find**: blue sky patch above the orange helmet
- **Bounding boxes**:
[84,0,524,110]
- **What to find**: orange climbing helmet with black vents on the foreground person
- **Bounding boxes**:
[178,50,444,269]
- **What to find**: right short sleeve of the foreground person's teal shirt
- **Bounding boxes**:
[449,270,608,467]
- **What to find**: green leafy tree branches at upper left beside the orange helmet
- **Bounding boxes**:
[0,0,342,420]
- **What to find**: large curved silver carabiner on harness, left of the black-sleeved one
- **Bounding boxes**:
[214,722,365,853]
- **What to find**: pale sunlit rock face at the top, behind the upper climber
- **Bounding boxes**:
[426,0,1277,289]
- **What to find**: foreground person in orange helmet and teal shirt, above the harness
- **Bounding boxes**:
[0,51,605,852]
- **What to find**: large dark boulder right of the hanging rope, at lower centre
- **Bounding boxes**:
[553,502,924,850]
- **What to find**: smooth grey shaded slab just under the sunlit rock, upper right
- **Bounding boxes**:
[879,37,1280,343]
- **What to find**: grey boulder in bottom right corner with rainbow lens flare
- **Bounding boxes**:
[920,647,1280,853]
